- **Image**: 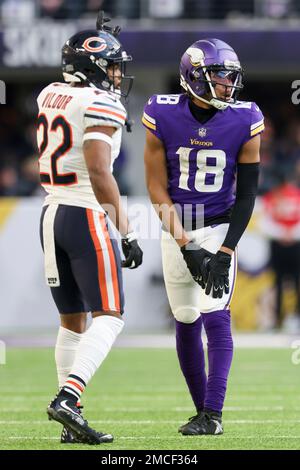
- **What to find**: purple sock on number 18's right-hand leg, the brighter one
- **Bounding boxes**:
[202,310,233,413]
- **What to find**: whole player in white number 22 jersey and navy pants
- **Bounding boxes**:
[37,12,143,444]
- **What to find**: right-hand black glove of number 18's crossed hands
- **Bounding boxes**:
[205,251,231,299]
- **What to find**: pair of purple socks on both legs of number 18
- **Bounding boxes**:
[176,310,233,413]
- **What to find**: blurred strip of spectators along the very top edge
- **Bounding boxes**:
[0,0,300,22]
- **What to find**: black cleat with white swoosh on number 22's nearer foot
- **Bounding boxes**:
[47,397,113,444]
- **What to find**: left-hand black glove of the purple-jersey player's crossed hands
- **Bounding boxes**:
[181,241,214,289]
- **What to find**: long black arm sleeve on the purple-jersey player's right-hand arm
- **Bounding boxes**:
[223,163,259,250]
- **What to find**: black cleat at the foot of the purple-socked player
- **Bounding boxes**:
[178,411,223,436]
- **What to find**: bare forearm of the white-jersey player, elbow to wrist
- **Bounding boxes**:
[90,171,130,235]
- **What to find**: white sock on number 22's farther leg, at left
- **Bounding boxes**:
[55,326,82,388]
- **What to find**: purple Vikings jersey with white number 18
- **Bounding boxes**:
[142,94,264,219]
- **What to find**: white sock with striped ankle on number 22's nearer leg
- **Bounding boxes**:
[64,315,124,397]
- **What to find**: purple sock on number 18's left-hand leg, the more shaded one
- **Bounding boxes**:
[175,317,207,411]
